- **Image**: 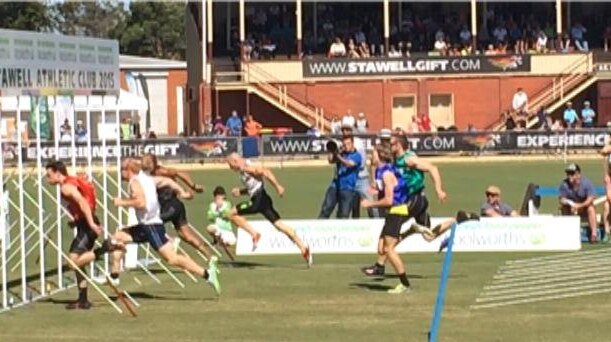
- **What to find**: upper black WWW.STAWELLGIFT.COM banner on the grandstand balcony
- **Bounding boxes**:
[302,55,530,78]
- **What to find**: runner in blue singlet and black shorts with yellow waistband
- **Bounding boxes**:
[361,144,427,294]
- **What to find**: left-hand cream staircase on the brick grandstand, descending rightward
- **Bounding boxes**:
[215,62,331,133]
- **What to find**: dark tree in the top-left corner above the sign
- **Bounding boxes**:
[0,2,52,32]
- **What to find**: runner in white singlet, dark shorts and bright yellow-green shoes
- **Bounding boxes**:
[97,159,221,295]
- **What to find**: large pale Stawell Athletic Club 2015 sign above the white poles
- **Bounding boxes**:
[0,29,120,95]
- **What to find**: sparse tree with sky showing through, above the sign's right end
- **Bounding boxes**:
[52,0,128,39]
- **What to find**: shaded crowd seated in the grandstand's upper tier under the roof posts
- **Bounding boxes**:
[233,2,611,59]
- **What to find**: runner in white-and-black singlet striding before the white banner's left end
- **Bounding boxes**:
[227,153,312,267]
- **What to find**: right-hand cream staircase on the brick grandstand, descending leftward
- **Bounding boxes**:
[488,53,597,131]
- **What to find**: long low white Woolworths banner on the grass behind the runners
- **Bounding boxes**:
[236,216,581,255]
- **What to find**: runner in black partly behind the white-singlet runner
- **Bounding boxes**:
[142,154,212,260]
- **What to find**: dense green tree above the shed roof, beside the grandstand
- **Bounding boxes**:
[119,1,186,60]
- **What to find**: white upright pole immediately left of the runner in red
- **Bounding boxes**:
[35,97,49,296]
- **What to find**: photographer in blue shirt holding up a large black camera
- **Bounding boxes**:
[318,135,363,218]
